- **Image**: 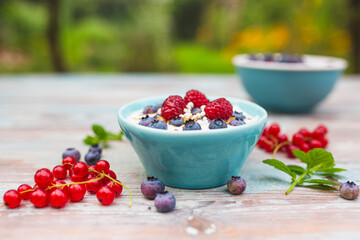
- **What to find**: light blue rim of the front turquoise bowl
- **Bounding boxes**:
[117,95,268,137]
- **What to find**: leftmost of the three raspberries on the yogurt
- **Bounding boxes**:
[161,95,186,120]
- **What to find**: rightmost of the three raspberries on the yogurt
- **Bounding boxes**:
[205,98,233,121]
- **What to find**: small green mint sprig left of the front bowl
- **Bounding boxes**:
[83,124,124,148]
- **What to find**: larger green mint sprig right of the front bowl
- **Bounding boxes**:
[263,148,346,195]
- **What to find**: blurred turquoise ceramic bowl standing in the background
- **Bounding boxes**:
[233,54,346,113]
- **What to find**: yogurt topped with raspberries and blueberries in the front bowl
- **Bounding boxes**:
[129,90,258,131]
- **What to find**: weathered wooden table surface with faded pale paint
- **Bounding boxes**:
[0,75,360,240]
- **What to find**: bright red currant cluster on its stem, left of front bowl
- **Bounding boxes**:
[4,156,132,208]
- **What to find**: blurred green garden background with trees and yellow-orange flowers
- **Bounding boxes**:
[0,0,360,73]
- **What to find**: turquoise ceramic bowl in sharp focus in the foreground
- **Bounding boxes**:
[118,97,267,189]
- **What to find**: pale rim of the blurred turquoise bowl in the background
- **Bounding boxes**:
[232,54,348,72]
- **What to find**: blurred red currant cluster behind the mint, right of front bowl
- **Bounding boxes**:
[257,123,328,158]
